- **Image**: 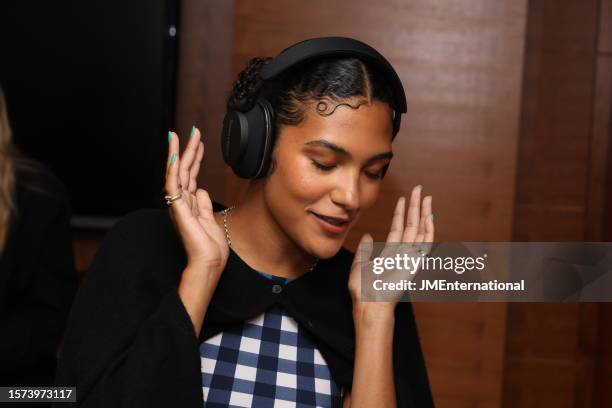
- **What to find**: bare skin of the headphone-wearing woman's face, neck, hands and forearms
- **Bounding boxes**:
[166,99,434,407]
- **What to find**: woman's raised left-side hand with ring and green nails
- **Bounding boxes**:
[165,127,229,278]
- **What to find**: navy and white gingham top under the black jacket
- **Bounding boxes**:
[200,272,343,408]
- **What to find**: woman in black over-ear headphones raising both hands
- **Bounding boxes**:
[57,36,434,407]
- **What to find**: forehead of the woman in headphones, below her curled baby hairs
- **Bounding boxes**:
[286,99,392,153]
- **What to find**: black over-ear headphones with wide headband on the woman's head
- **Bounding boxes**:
[221,37,406,179]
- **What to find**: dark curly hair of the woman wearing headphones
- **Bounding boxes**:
[227,57,394,173]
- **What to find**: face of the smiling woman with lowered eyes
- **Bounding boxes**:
[264,100,392,259]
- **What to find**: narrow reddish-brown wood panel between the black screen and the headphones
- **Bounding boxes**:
[176,0,234,203]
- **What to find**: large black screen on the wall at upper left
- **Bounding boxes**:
[0,0,178,226]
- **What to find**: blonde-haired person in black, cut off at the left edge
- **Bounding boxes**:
[0,83,77,396]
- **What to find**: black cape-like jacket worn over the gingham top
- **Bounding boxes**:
[56,210,433,408]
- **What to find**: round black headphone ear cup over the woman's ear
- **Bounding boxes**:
[221,98,273,179]
